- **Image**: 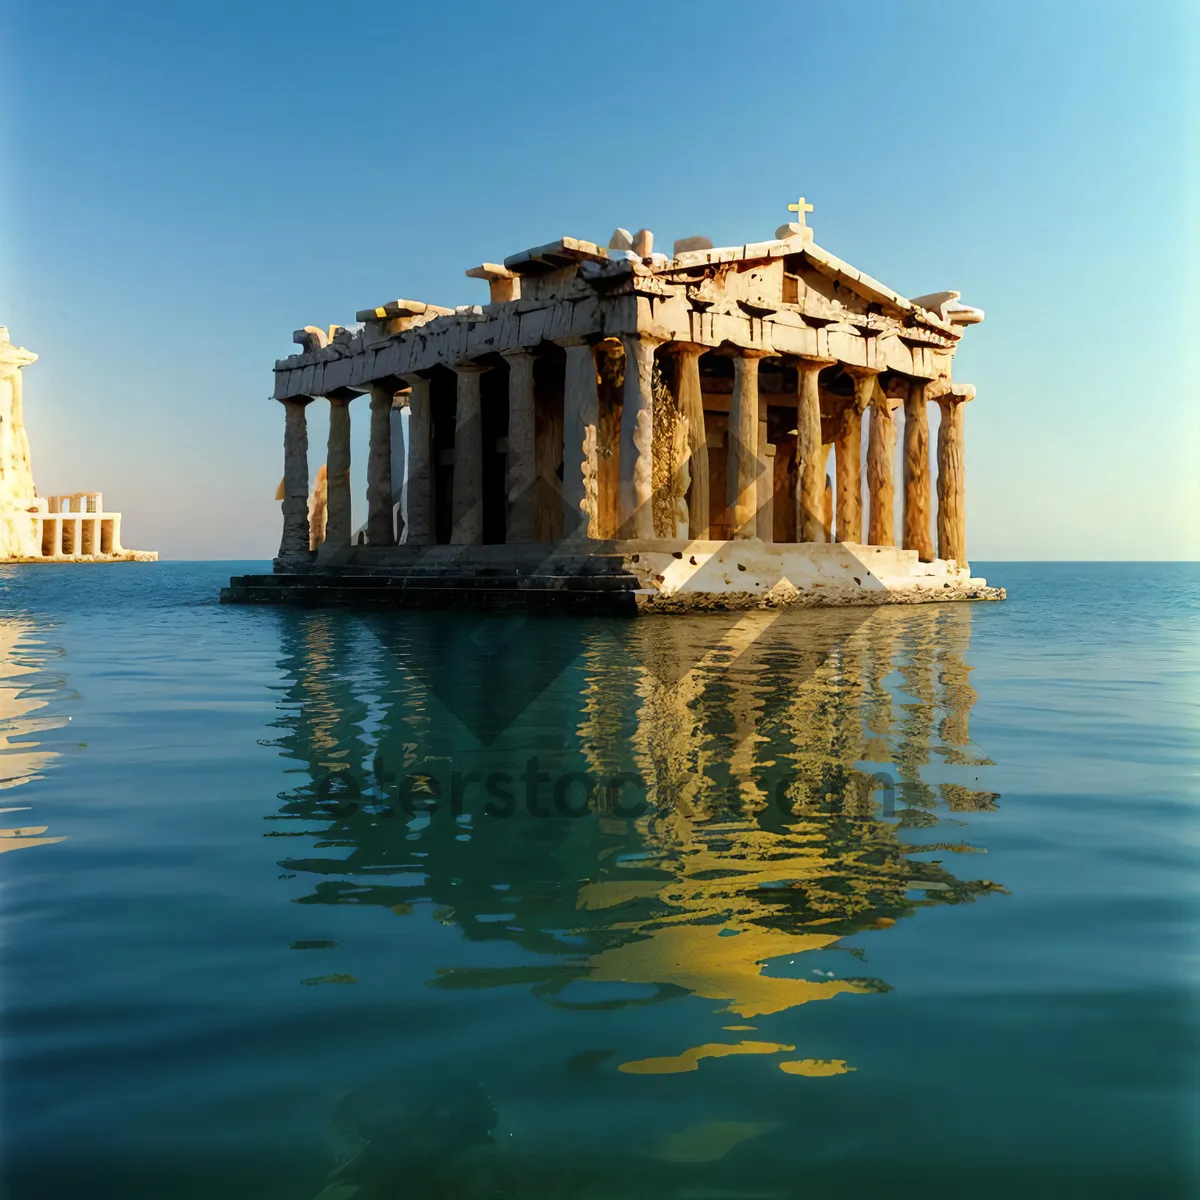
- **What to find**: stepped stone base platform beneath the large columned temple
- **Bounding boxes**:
[221,539,1004,616]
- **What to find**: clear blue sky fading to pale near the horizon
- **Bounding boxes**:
[0,0,1200,559]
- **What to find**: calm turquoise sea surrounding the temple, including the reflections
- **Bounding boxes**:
[0,563,1200,1200]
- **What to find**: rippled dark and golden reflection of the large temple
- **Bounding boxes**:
[271,606,997,1019]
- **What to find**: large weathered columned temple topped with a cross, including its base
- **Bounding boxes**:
[224,199,1003,611]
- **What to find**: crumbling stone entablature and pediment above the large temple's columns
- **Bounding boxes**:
[275,234,982,400]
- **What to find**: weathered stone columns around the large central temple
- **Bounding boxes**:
[280,335,968,563]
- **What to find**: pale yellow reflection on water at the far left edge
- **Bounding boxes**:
[0,617,66,854]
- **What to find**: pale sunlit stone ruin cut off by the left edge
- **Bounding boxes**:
[0,326,158,563]
